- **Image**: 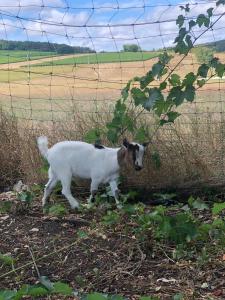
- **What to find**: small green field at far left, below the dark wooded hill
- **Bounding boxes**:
[0,50,56,64]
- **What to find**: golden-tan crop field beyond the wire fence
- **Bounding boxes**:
[0,53,225,121]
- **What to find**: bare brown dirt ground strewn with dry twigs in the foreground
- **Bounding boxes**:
[0,193,225,300]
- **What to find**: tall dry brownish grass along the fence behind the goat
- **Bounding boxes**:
[0,88,225,189]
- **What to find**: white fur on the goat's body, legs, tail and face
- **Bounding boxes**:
[37,136,144,208]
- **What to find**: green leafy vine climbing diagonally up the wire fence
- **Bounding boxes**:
[89,0,225,144]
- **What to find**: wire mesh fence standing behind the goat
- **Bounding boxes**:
[0,0,225,191]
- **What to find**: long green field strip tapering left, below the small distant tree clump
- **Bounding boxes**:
[38,52,159,66]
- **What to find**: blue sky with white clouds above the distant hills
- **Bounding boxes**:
[0,0,225,52]
